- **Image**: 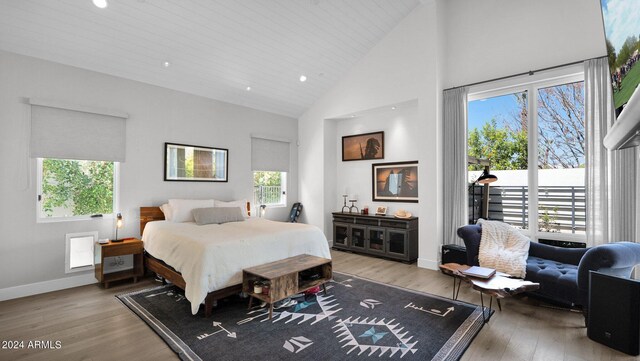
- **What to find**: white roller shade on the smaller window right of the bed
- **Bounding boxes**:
[251,137,291,172]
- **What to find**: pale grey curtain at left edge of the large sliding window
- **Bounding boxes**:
[443,87,469,245]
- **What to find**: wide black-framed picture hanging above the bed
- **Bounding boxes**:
[164,143,229,182]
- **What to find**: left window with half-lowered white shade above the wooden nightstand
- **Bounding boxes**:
[30,99,126,222]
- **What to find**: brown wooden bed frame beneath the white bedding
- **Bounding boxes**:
[140,202,251,317]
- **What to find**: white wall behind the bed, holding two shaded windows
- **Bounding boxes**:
[0,52,298,293]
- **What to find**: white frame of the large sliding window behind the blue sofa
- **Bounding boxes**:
[465,64,587,243]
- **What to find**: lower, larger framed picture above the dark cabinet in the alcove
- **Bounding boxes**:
[372,161,418,203]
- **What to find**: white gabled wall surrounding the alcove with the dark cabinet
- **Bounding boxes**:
[299,1,442,268]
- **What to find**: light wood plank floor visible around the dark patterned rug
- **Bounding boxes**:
[0,251,640,361]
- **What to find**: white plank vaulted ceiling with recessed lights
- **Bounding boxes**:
[0,0,419,117]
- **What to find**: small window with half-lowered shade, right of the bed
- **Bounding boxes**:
[251,137,291,207]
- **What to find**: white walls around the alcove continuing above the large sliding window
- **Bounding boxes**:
[299,0,606,268]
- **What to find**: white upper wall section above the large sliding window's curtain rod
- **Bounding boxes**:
[439,0,607,88]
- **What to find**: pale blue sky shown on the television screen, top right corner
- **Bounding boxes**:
[601,0,640,53]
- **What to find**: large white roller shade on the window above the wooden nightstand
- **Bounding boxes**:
[29,99,127,162]
